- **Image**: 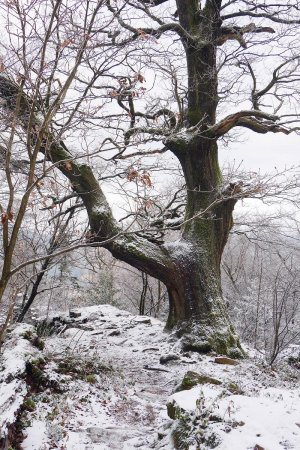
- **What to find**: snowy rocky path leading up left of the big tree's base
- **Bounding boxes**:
[23,306,180,450]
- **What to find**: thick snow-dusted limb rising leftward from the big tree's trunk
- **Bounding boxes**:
[0,74,172,282]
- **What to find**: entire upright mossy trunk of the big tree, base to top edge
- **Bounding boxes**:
[149,0,243,356]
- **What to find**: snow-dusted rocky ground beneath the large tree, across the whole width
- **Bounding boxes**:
[0,305,300,450]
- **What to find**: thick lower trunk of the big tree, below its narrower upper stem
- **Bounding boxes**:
[162,137,242,356]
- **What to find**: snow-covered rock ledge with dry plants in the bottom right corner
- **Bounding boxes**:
[169,385,300,450]
